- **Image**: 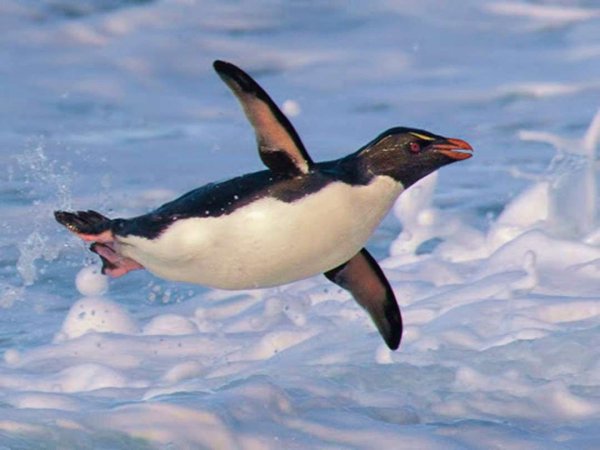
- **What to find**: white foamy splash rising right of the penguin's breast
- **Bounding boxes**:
[390,110,600,263]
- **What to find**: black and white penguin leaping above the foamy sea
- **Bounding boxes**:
[54,60,473,350]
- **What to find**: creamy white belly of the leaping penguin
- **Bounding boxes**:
[119,176,402,289]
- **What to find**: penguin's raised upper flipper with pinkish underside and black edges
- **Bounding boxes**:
[213,61,313,176]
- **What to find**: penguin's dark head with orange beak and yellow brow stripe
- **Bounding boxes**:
[357,127,473,188]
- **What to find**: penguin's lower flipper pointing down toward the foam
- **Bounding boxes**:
[325,248,402,350]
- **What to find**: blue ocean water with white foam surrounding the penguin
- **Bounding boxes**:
[0,0,600,450]
